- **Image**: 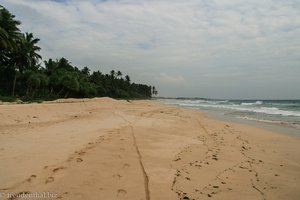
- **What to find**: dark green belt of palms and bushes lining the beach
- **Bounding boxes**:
[0,5,157,101]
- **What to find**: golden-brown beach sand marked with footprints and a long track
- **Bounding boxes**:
[0,98,300,200]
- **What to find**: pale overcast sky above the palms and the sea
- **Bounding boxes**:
[0,0,300,99]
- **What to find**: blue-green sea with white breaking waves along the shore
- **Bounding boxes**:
[165,99,300,136]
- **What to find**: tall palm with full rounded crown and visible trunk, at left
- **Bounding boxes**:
[11,33,42,96]
